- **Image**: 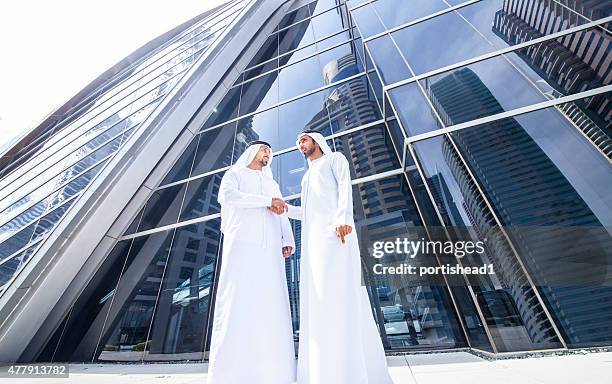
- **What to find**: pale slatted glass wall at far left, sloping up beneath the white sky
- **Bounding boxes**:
[0,1,246,291]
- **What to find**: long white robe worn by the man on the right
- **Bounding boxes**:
[288,152,392,384]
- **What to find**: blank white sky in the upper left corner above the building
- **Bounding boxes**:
[0,0,227,149]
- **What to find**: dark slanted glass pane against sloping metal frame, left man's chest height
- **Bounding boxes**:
[138,183,187,232]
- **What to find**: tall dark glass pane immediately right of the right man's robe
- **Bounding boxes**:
[353,176,465,349]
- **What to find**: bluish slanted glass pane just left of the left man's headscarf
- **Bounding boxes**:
[191,123,236,176]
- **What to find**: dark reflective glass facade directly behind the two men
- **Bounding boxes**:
[0,0,612,361]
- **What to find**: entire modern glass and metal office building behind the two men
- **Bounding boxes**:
[0,0,612,362]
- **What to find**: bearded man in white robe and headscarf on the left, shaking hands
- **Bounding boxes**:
[208,141,295,384]
